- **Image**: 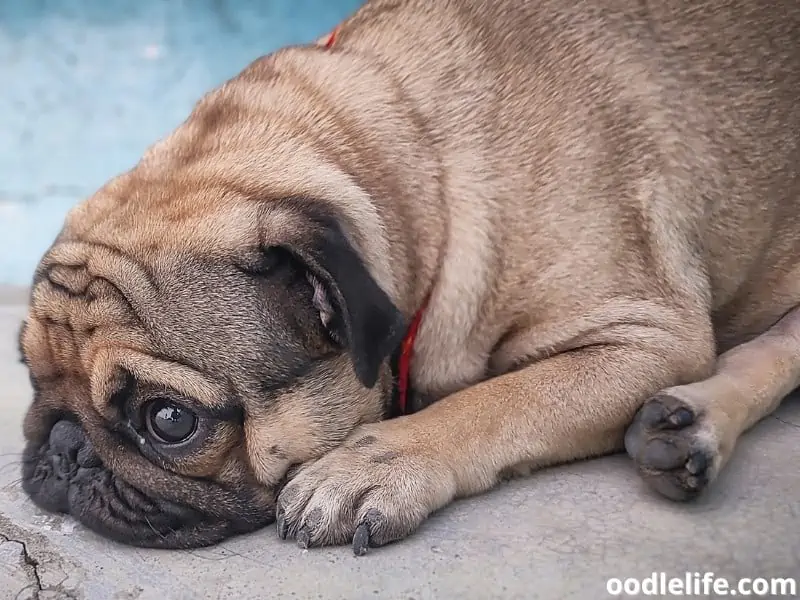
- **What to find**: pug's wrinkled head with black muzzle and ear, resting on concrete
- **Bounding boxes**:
[20,154,403,548]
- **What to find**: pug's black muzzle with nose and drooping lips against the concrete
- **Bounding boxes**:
[22,421,275,549]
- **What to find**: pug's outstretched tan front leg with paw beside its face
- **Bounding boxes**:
[278,324,715,553]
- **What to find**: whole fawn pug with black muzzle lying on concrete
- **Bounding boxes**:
[15,0,800,553]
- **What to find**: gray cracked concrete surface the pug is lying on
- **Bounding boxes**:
[0,290,800,600]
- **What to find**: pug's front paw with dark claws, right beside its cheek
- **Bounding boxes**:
[277,421,455,555]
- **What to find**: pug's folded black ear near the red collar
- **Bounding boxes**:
[287,207,406,388]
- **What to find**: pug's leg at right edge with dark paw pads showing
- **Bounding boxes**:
[625,308,800,500]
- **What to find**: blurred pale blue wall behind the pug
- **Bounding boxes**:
[0,0,361,285]
